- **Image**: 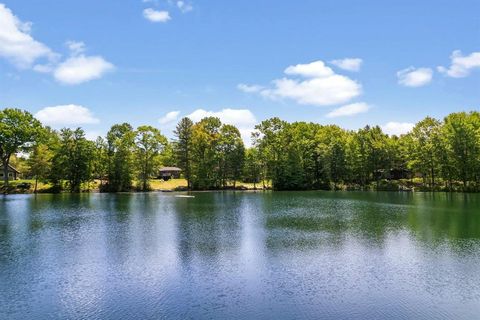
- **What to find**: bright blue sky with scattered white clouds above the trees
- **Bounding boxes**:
[0,0,480,141]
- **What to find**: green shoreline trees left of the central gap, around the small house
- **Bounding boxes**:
[0,109,245,192]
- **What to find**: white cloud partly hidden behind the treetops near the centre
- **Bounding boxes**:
[187,108,257,145]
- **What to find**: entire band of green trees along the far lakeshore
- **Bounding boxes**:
[0,109,480,192]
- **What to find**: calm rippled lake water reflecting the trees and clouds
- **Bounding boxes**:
[0,192,480,319]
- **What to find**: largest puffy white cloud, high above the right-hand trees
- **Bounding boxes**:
[243,60,362,106]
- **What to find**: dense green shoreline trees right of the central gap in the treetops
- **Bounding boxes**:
[250,112,480,191]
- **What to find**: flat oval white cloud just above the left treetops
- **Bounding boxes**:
[35,104,100,126]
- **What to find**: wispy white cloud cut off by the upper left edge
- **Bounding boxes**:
[0,3,57,69]
